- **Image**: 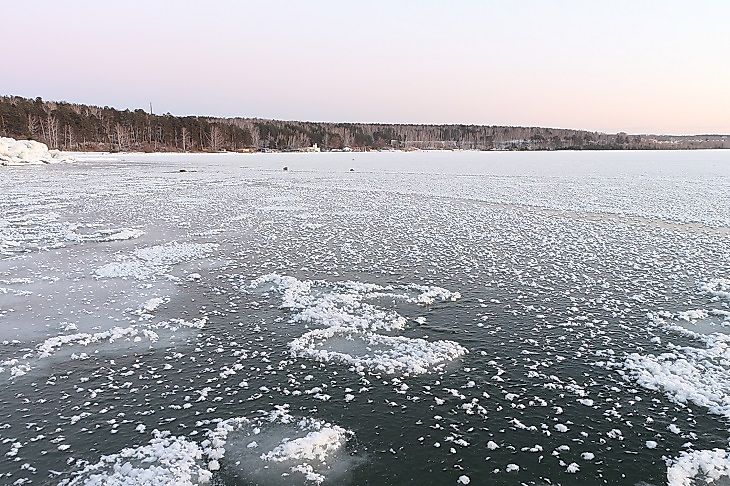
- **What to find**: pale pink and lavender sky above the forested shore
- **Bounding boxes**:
[0,0,730,134]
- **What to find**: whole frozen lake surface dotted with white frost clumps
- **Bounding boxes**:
[0,151,730,486]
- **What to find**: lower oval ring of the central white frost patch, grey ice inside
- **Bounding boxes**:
[289,327,468,374]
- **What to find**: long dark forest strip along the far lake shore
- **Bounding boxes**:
[0,96,730,152]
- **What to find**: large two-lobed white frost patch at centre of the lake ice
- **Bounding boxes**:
[249,274,467,374]
